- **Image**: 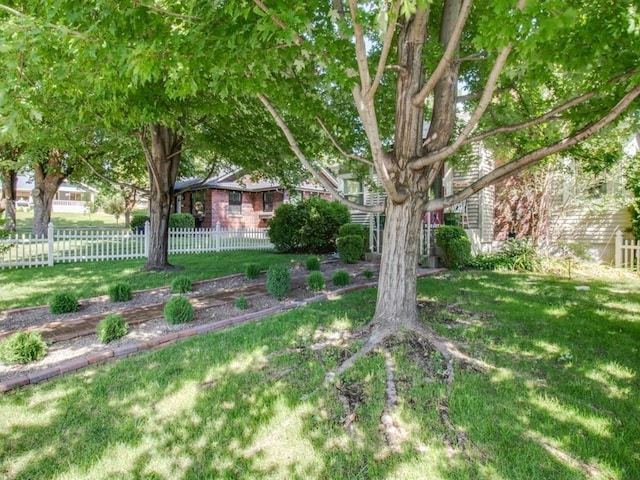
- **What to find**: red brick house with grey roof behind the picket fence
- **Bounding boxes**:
[174,170,337,228]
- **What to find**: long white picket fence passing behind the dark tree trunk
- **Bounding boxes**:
[0,222,273,269]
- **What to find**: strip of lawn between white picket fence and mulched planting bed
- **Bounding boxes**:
[0,250,307,310]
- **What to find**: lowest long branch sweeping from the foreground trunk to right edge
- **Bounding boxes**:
[427,85,640,211]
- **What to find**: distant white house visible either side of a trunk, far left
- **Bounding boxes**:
[9,175,98,213]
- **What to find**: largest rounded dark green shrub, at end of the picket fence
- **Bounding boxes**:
[269,197,350,253]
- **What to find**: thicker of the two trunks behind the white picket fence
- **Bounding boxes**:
[32,150,71,236]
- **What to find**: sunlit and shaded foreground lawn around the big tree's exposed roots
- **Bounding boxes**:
[0,272,640,480]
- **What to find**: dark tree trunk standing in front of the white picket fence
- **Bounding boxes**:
[140,125,182,271]
